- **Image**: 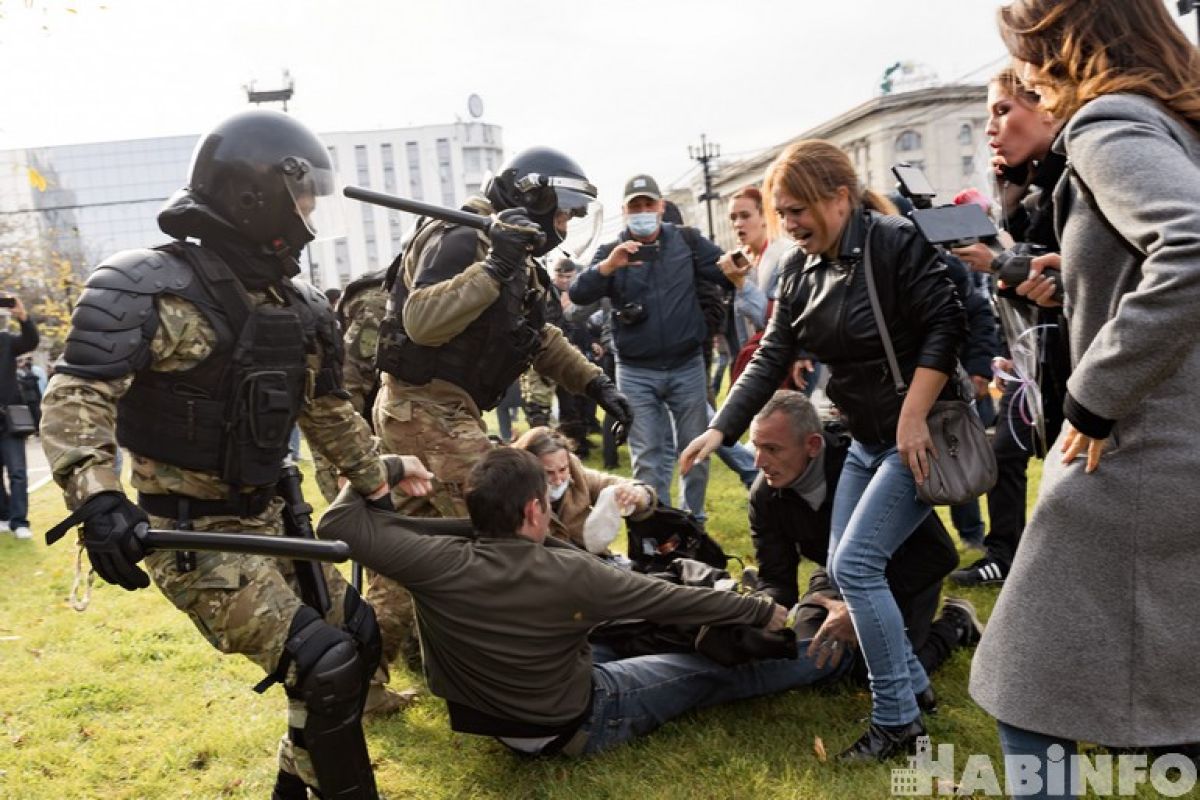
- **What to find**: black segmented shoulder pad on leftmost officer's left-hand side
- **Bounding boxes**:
[55,249,193,380]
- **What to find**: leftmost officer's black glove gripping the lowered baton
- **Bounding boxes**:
[78,492,150,591]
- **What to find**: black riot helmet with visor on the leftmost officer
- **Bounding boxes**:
[160,109,341,259]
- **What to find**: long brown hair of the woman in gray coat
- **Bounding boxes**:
[998,0,1200,131]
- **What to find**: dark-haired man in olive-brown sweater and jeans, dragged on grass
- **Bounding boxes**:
[317,449,852,756]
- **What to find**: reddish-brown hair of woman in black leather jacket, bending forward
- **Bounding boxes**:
[762,139,898,236]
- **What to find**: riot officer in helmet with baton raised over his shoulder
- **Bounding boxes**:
[374,148,632,517]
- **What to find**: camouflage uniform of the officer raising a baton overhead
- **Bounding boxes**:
[374,198,602,517]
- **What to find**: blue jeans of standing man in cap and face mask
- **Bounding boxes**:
[617,353,708,519]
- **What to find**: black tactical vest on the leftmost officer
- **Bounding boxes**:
[116,243,340,487]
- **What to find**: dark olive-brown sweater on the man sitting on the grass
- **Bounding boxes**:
[317,472,772,727]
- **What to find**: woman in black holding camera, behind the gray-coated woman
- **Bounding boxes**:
[950,68,1070,587]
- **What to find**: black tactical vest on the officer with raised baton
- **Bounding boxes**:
[376,221,546,410]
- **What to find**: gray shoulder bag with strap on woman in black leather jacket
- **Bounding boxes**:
[863,225,996,505]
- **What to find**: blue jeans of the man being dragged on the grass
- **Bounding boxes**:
[581,639,853,754]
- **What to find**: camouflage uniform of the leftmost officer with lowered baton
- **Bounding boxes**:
[41,291,386,786]
